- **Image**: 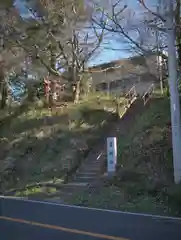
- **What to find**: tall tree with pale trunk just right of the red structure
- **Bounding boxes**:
[12,0,104,102]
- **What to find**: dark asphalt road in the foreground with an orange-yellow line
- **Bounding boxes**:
[0,198,181,240]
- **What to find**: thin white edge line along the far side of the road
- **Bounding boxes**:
[0,196,181,221]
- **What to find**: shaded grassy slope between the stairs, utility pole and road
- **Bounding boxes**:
[68,98,181,218]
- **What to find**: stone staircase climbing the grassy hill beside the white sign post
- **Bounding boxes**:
[46,84,153,202]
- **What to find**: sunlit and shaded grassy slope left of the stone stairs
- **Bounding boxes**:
[0,96,121,195]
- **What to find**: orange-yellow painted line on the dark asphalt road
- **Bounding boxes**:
[0,216,129,240]
